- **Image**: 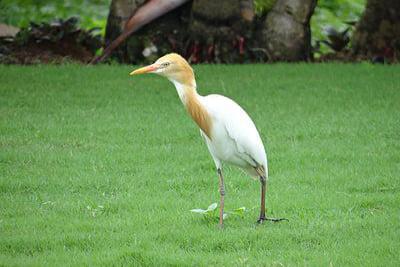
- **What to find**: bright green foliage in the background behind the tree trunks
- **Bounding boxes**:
[0,0,366,57]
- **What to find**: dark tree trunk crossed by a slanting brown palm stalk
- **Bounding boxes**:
[106,0,191,64]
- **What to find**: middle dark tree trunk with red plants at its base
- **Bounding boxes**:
[188,0,254,63]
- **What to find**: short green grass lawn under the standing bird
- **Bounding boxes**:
[0,64,400,266]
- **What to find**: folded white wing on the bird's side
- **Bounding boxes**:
[204,95,267,170]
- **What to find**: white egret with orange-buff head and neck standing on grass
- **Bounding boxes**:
[130,53,285,226]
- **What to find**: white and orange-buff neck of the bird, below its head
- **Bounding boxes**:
[172,80,212,139]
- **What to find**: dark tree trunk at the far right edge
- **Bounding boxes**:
[352,0,400,62]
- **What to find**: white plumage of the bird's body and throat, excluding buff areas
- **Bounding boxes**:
[172,81,268,178]
